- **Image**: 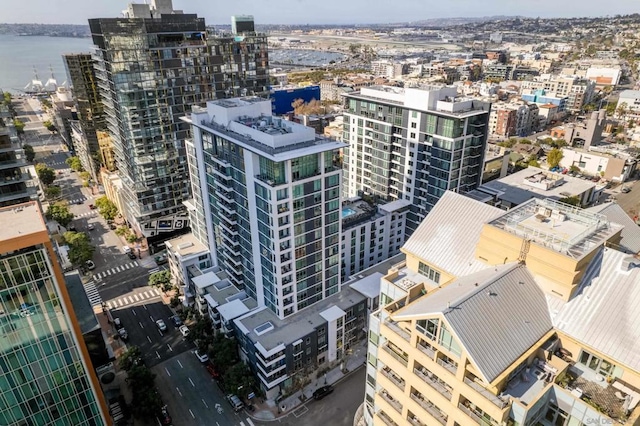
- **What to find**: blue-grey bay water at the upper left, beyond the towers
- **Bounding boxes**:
[0,34,93,93]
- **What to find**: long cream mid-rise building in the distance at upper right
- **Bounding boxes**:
[521,74,596,112]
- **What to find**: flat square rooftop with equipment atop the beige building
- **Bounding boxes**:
[489,198,622,259]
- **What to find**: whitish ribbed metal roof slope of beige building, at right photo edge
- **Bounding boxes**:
[547,249,640,371]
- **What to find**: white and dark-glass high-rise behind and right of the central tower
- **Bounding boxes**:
[343,86,490,235]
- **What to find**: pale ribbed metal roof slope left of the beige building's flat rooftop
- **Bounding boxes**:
[402,191,504,277]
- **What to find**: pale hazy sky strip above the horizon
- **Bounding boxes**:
[0,0,640,24]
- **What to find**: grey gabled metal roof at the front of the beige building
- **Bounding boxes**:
[392,263,553,383]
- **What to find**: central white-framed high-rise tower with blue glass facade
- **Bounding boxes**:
[186,97,345,318]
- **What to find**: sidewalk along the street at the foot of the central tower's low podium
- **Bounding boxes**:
[245,339,367,421]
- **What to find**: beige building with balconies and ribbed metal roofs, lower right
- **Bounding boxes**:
[363,192,640,426]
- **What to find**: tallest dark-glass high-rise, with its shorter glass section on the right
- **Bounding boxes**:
[89,0,268,246]
